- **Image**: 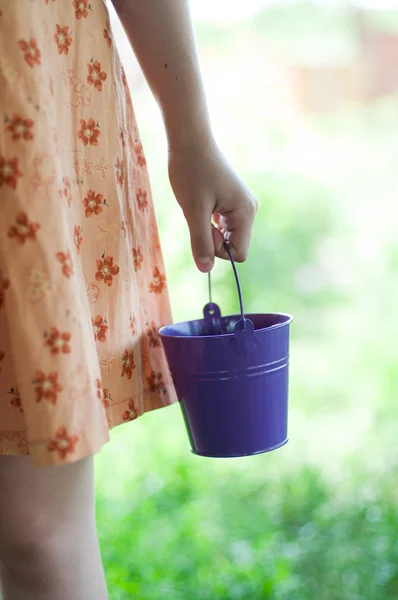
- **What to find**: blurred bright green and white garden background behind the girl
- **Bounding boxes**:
[96,0,398,600]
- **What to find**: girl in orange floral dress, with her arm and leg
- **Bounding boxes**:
[0,0,257,600]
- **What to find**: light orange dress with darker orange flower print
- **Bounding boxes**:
[0,0,176,466]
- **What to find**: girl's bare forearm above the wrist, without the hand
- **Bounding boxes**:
[113,0,210,147]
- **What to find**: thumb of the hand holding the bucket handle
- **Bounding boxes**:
[185,205,215,273]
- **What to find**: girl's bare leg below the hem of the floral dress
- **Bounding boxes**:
[0,456,108,600]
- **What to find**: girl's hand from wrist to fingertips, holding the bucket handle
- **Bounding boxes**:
[169,140,258,273]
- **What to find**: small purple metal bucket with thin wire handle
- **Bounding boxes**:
[159,244,292,458]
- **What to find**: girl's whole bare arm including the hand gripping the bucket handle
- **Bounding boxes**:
[113,0,257,272]
